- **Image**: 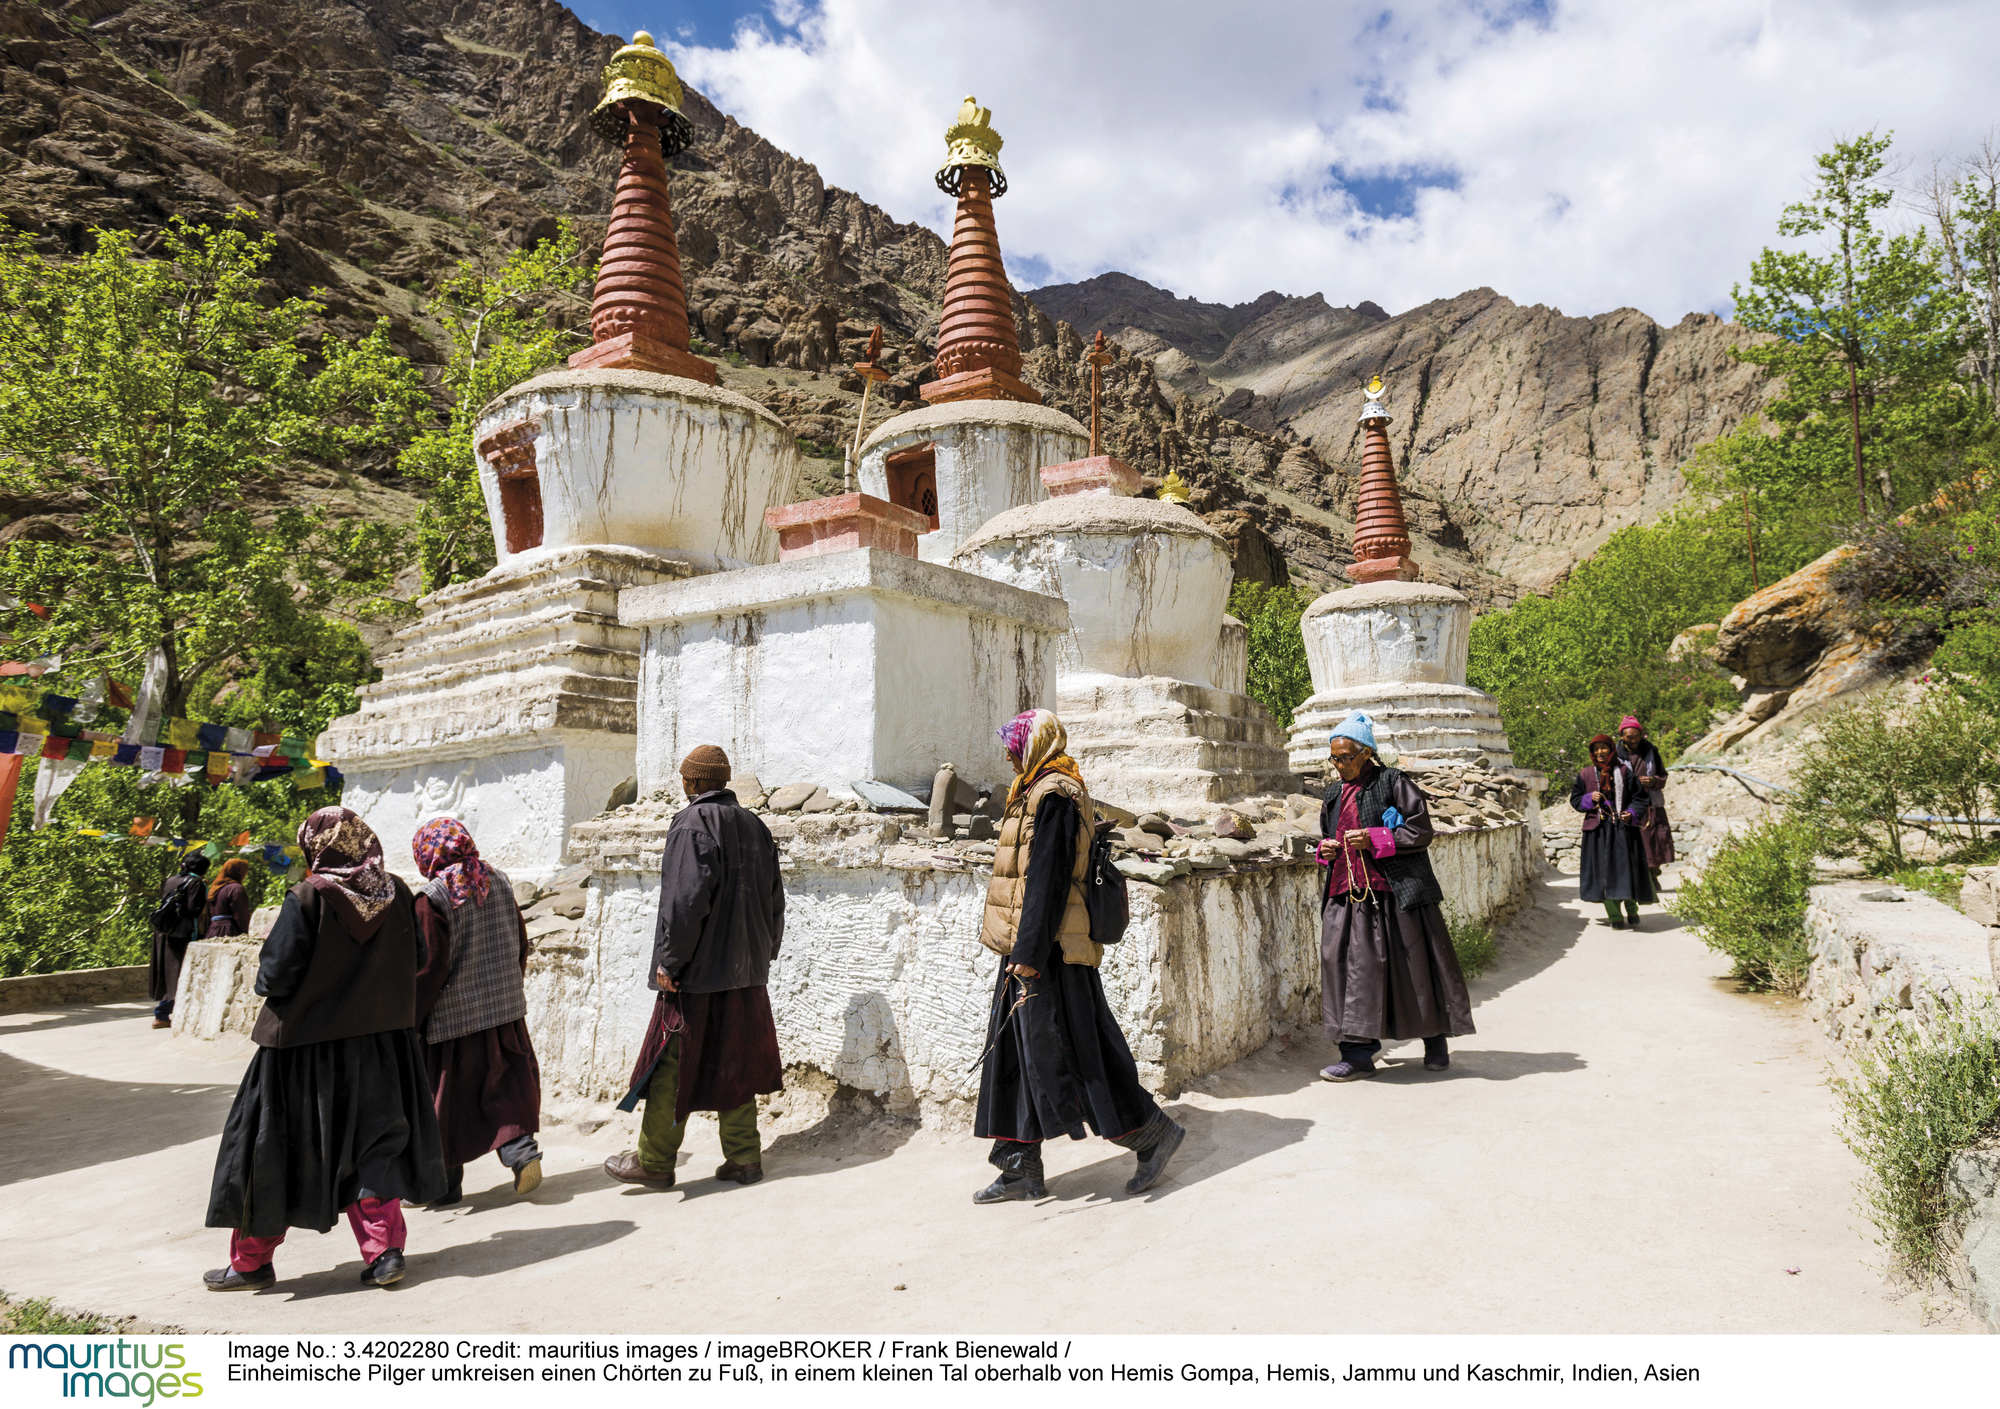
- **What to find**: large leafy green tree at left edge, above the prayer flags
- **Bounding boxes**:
[0,218,428,723]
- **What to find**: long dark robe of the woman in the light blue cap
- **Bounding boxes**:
[1320,775,1476,1043]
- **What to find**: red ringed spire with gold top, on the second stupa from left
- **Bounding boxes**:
[922,98,1042,404]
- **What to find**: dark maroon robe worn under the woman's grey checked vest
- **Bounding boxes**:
[416,895,542,1167]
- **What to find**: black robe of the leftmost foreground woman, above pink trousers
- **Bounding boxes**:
[208,897,446,1237]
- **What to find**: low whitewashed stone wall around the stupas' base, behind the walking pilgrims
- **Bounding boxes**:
[176,805,1540,1127]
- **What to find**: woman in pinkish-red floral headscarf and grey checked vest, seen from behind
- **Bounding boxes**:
[410,817,542,1205]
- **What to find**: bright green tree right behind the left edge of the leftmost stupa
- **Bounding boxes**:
[398,220,596,592]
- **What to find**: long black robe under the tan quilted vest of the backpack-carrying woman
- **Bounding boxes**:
[972,793,1160,1141]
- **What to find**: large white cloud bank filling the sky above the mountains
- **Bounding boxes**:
[672,0,2000,320]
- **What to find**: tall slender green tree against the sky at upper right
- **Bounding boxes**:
[1710,132,1982,516]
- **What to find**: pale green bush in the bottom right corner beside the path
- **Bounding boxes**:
[1834,999,2000,1281]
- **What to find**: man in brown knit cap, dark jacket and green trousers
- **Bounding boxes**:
[604,745,784,1189]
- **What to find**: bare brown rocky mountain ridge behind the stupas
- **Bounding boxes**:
[0,0,1748,602]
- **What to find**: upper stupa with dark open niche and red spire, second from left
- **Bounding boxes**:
[860,98,1090,562]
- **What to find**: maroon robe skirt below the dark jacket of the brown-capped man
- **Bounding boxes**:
[618,985,784,1119]
